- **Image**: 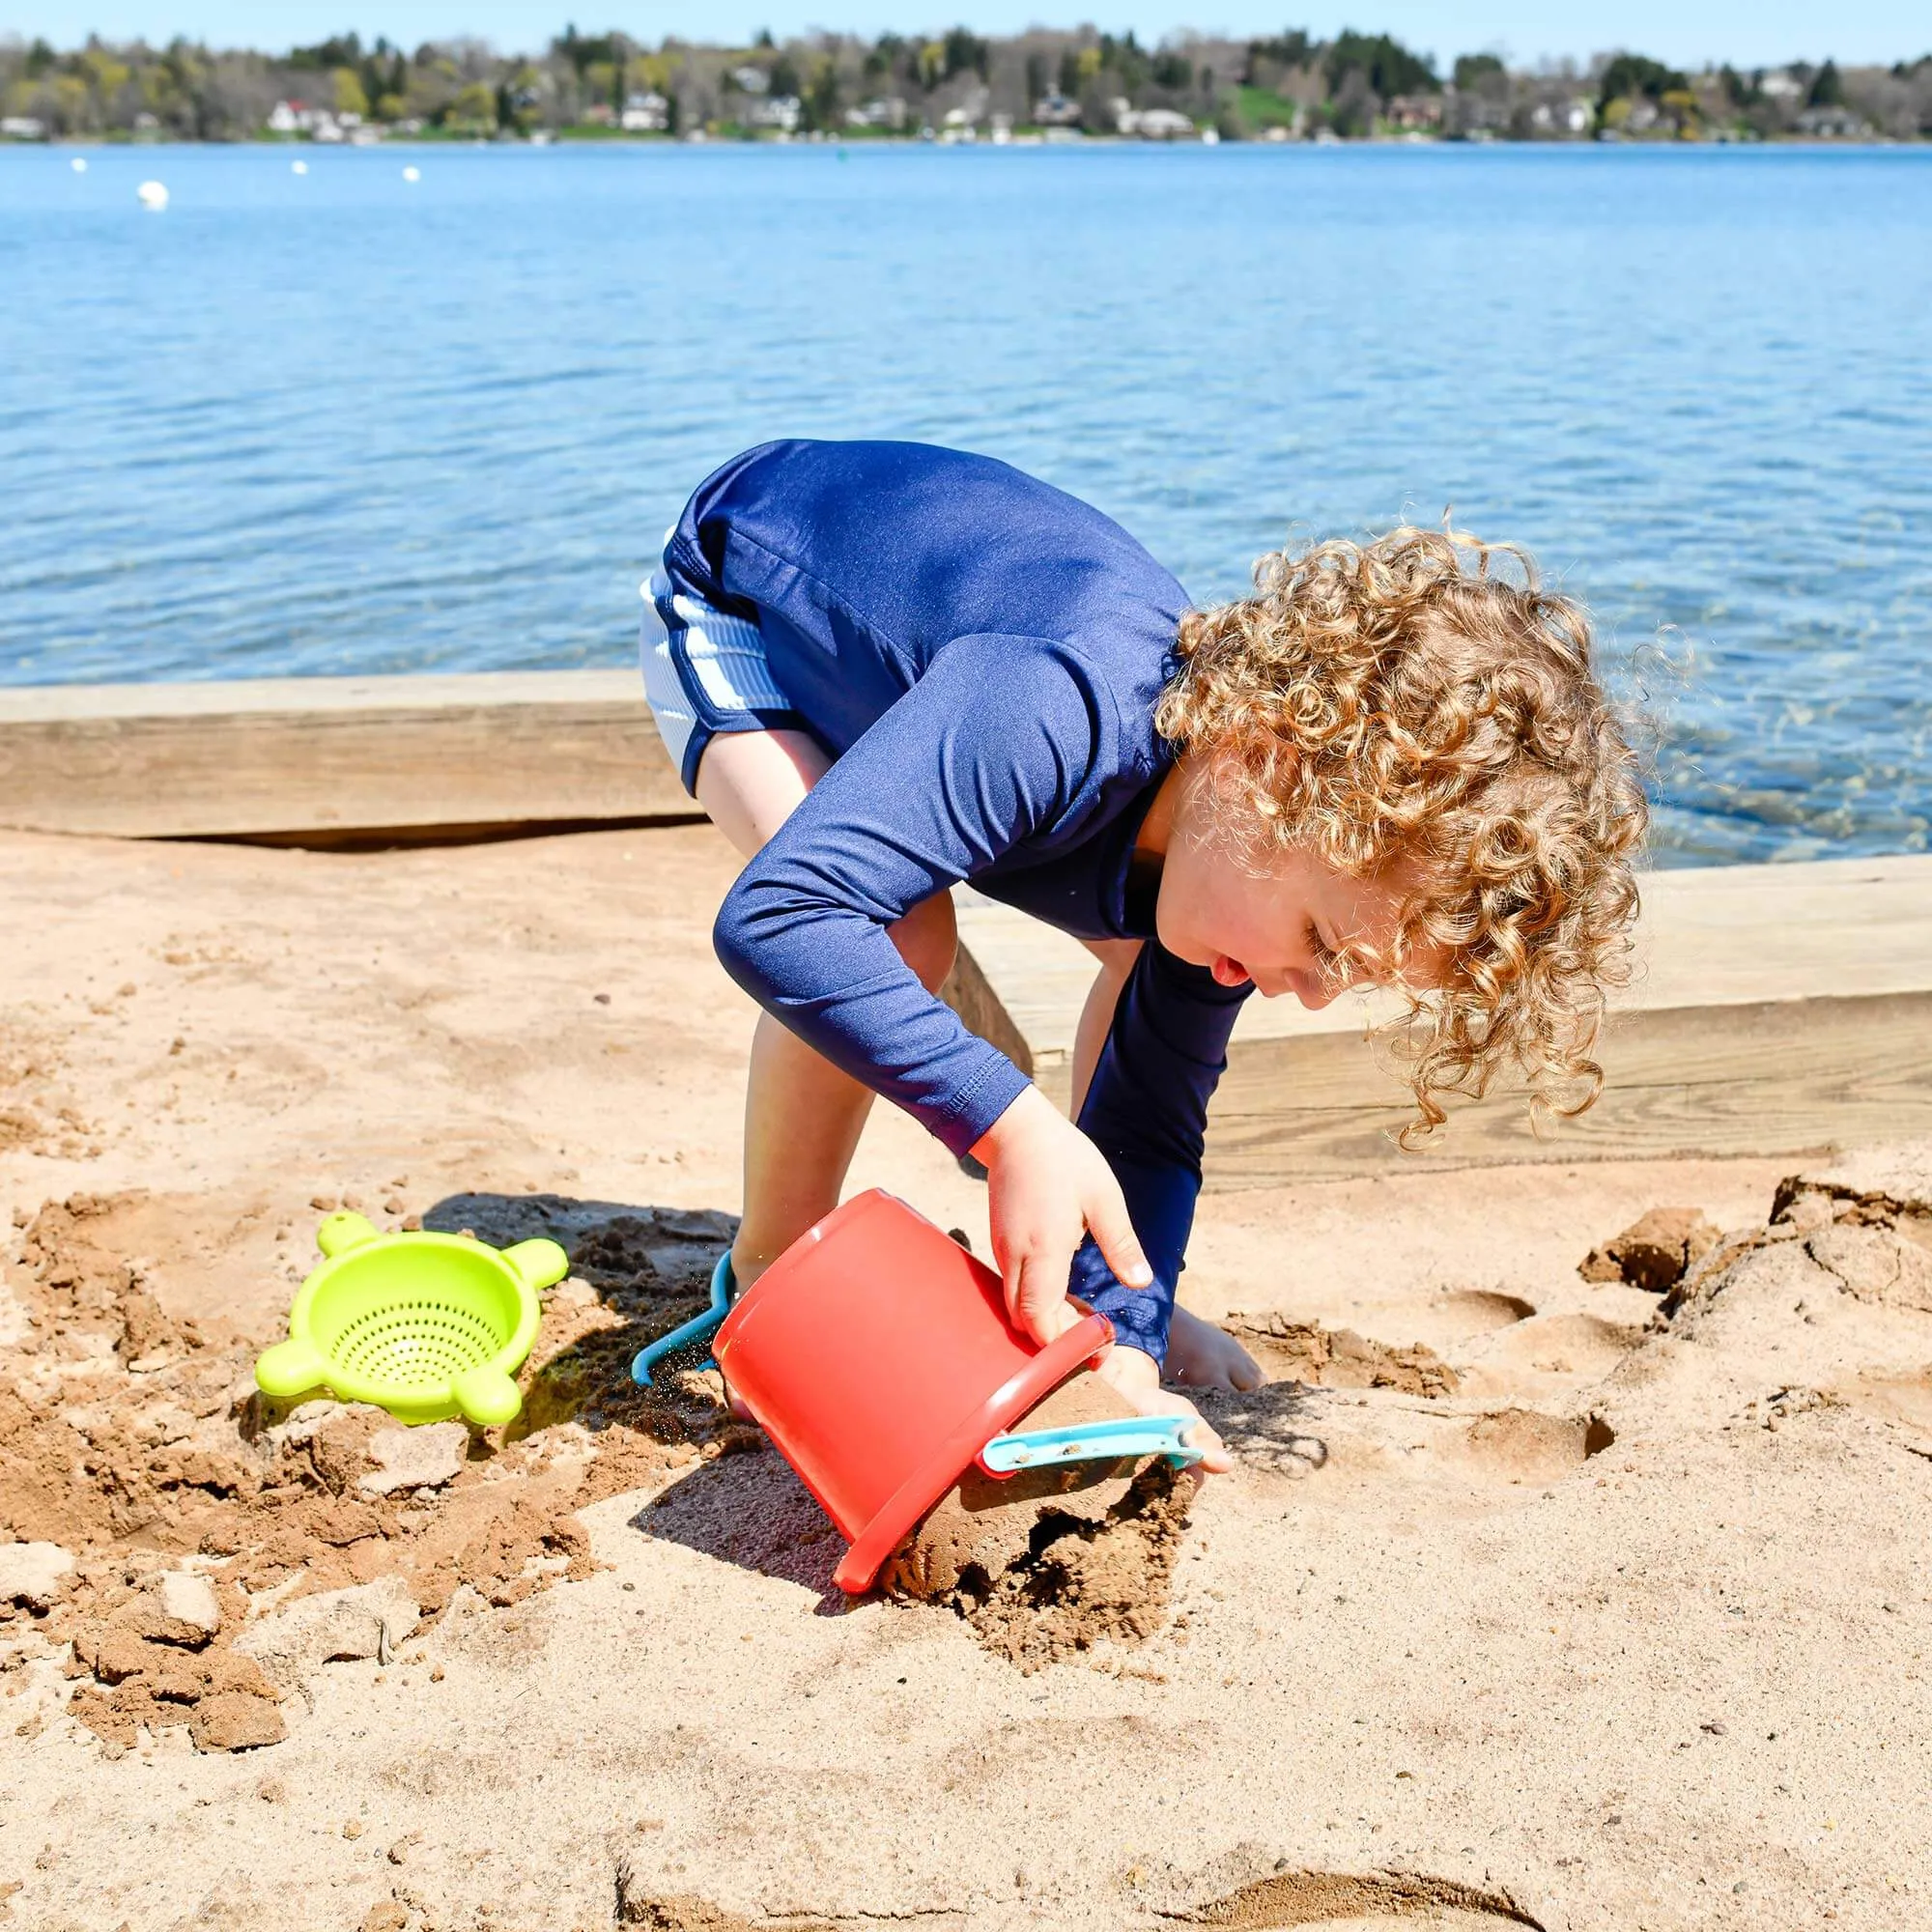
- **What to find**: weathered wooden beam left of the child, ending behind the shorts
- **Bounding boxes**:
[0,670,696,838]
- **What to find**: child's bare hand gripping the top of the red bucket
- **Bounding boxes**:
[972,1088,1159,1352]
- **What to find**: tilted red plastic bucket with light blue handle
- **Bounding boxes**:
[713,1188,1198,1596]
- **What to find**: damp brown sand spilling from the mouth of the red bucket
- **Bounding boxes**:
[881,1374,1194,1671]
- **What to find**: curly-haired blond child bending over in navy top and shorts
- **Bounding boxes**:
[643,442,1646,1470]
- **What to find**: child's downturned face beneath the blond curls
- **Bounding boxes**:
[1155,773,1439,1010]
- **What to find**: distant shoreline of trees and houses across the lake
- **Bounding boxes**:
[0,27,1932,141]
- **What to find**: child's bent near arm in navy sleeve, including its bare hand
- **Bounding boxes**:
[715,636,1151,1298]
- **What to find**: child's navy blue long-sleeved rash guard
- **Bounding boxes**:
[665,442,1250,1360]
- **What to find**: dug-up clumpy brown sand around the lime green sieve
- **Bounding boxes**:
[0,1194,734,1750]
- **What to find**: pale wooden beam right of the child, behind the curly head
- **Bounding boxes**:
[956,856,1932,1188]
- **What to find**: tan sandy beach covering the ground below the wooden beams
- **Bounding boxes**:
[0,827,1932,1932]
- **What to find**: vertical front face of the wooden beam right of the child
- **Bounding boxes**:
[1206,993,1932,1190]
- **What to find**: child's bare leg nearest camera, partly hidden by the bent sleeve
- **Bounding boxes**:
[697,730,956,1289]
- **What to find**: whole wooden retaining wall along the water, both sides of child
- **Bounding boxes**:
[0,670,1932,1188]
